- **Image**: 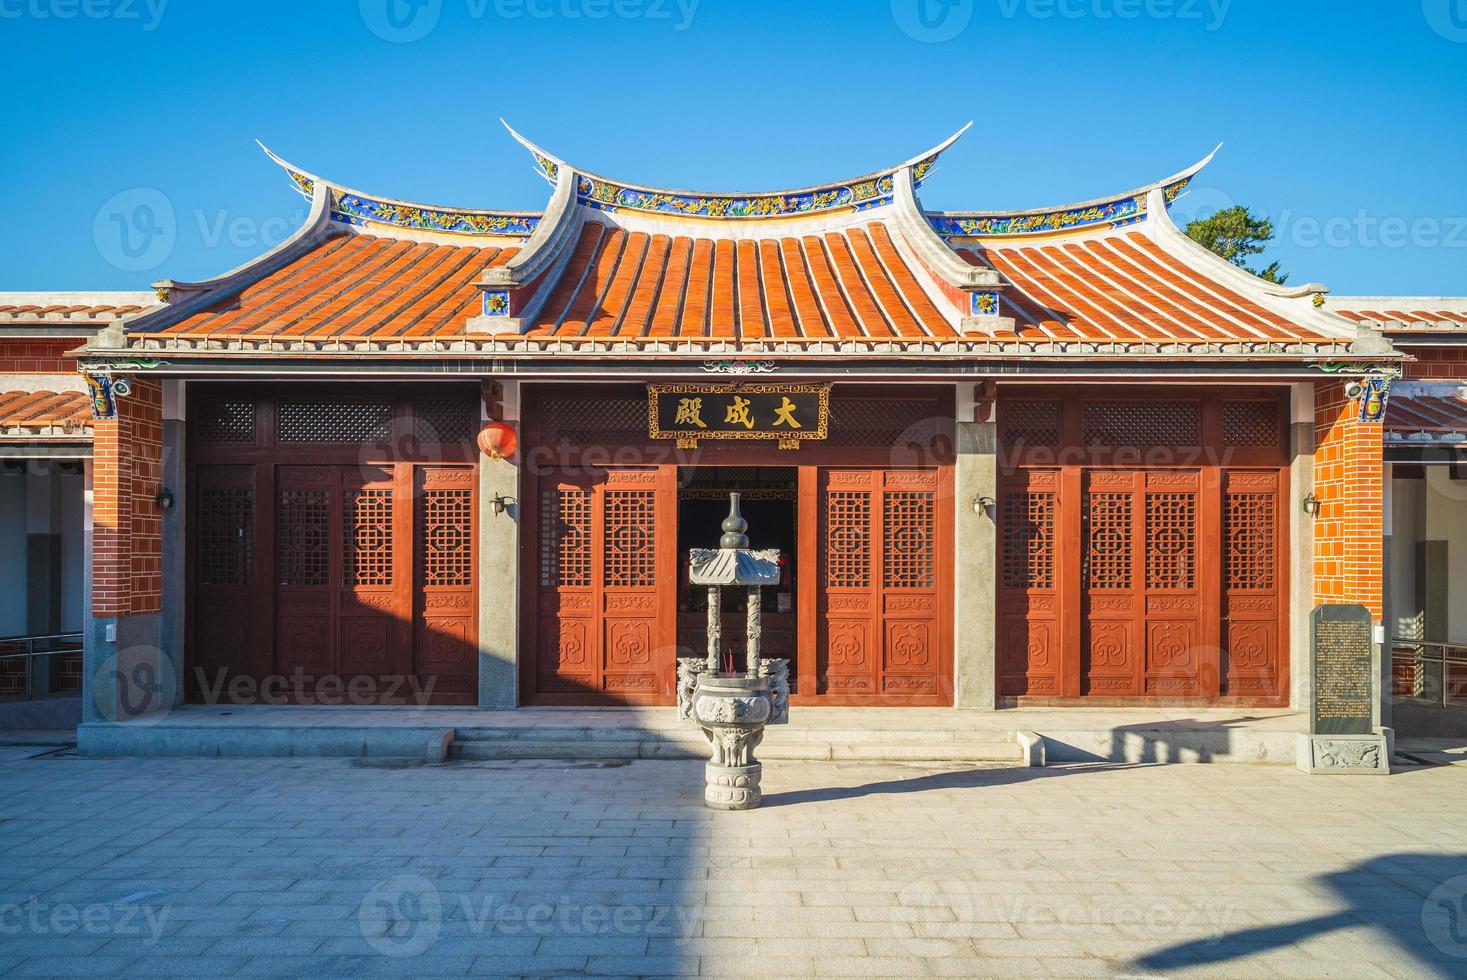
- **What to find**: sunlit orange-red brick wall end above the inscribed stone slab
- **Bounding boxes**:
[1314,381,1385,619]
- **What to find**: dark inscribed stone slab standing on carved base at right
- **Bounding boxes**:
[1309,606,1376,735]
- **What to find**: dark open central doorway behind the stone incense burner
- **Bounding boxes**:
[678,467,800,684]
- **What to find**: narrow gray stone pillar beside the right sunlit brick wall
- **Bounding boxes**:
[1284,384,1314,710]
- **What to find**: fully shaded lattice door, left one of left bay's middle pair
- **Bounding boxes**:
[274,467,342,678]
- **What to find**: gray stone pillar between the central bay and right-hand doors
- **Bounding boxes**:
[954,384,998,710]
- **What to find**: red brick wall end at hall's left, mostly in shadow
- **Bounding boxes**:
[92,380,163,616]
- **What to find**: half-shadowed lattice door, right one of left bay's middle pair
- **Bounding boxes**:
[334,467,412,697]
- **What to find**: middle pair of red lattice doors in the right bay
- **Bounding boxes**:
[1080,469,1216,697]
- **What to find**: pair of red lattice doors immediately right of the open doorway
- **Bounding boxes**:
[816,469,952,704]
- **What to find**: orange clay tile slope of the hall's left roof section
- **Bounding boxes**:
[145,235,515,340]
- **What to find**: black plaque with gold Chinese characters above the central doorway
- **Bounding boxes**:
[647,384,830,449]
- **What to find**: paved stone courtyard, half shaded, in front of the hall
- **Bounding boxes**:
[0,745,1467,977]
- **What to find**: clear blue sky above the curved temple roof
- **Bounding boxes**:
[0,0,1467,295]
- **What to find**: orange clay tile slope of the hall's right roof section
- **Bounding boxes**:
[956,230,1325,343]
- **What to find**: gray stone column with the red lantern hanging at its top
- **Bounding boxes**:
[478,381,519,709]
